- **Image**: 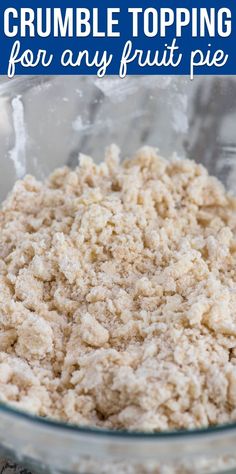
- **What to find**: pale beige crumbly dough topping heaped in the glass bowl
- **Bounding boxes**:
[0,146,236,431]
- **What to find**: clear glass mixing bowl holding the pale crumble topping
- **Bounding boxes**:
[0,76,236,474]
